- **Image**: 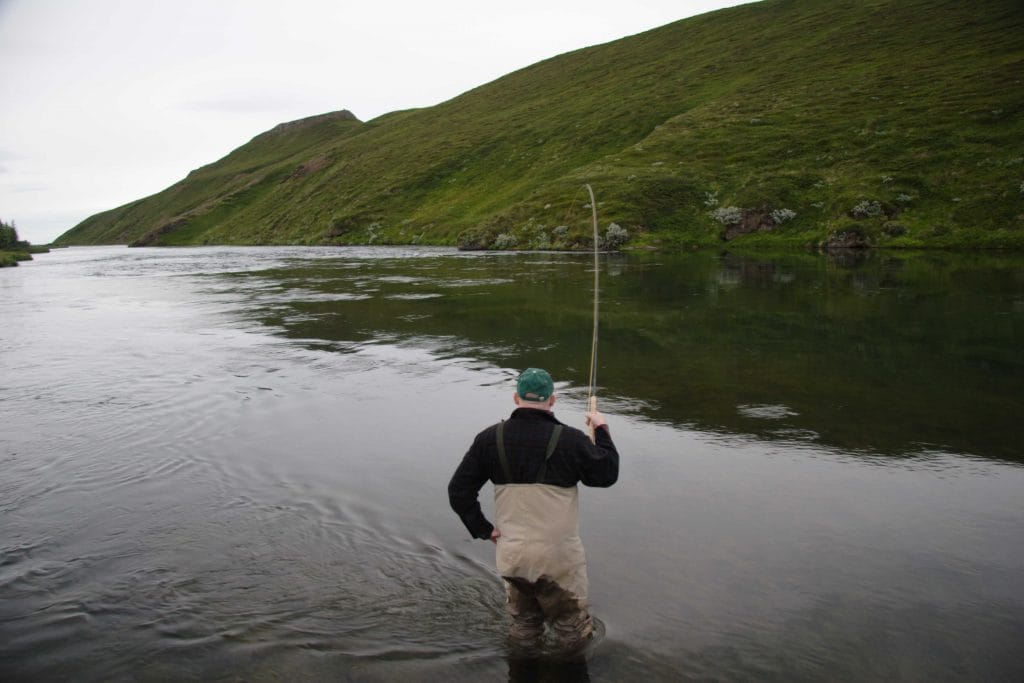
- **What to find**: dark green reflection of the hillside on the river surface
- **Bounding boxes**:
[226,253,1024,461]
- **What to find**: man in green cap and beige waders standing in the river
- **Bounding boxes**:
[449,368,618,649]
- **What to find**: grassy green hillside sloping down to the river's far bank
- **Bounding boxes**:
[57,0,1024,248]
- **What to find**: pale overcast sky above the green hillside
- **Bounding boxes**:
[0,0,749,244]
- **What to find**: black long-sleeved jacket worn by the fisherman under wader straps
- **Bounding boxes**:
[449,408,618,539]
